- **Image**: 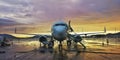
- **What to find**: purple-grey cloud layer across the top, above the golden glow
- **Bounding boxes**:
[0,0,120,24]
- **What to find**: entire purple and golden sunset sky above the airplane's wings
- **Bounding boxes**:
[0,0,120,33]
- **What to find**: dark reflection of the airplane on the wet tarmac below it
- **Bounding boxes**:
[38,43,84,60]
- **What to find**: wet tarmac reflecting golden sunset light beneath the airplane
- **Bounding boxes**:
[0,40,120,60]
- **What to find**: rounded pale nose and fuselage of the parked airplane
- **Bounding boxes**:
[52,22,68,41]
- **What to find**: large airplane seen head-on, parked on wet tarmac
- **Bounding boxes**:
[15,20,106,49]
